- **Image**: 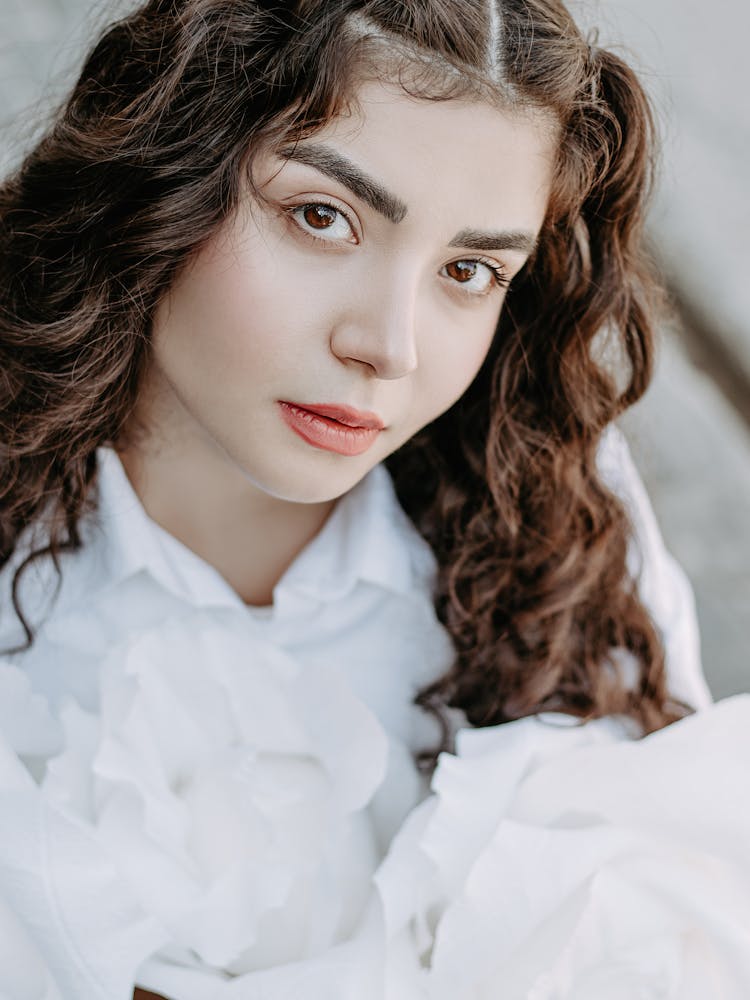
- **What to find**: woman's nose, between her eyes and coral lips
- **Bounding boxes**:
[330,268,418,379]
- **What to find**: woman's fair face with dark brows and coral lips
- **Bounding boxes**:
[141,83,555,502]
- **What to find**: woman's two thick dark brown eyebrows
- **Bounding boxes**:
[279,143,537,255]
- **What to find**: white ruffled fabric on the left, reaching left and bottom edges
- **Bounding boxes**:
[0,609,412,1000]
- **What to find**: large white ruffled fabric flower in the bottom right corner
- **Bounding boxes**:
[376,696,750,1000]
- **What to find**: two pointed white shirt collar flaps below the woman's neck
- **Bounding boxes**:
[86,448,434,611]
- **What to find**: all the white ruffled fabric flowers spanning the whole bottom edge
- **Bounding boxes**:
[0,609,750,1000]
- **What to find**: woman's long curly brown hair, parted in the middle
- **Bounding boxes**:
[0,0,685,748]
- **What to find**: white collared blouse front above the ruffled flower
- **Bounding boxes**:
[0,449,452,764]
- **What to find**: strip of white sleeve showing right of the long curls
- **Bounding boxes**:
[597,425,712,709]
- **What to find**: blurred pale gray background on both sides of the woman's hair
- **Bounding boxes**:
[0,0,750,697]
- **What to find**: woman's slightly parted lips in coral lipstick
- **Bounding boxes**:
[279,400,385,455]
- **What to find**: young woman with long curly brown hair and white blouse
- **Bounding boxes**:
[0,0,728,1000]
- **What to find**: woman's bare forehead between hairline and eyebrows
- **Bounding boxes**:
[276,82,557,237]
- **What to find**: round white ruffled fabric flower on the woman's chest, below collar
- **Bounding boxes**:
[37,611,396,977]
